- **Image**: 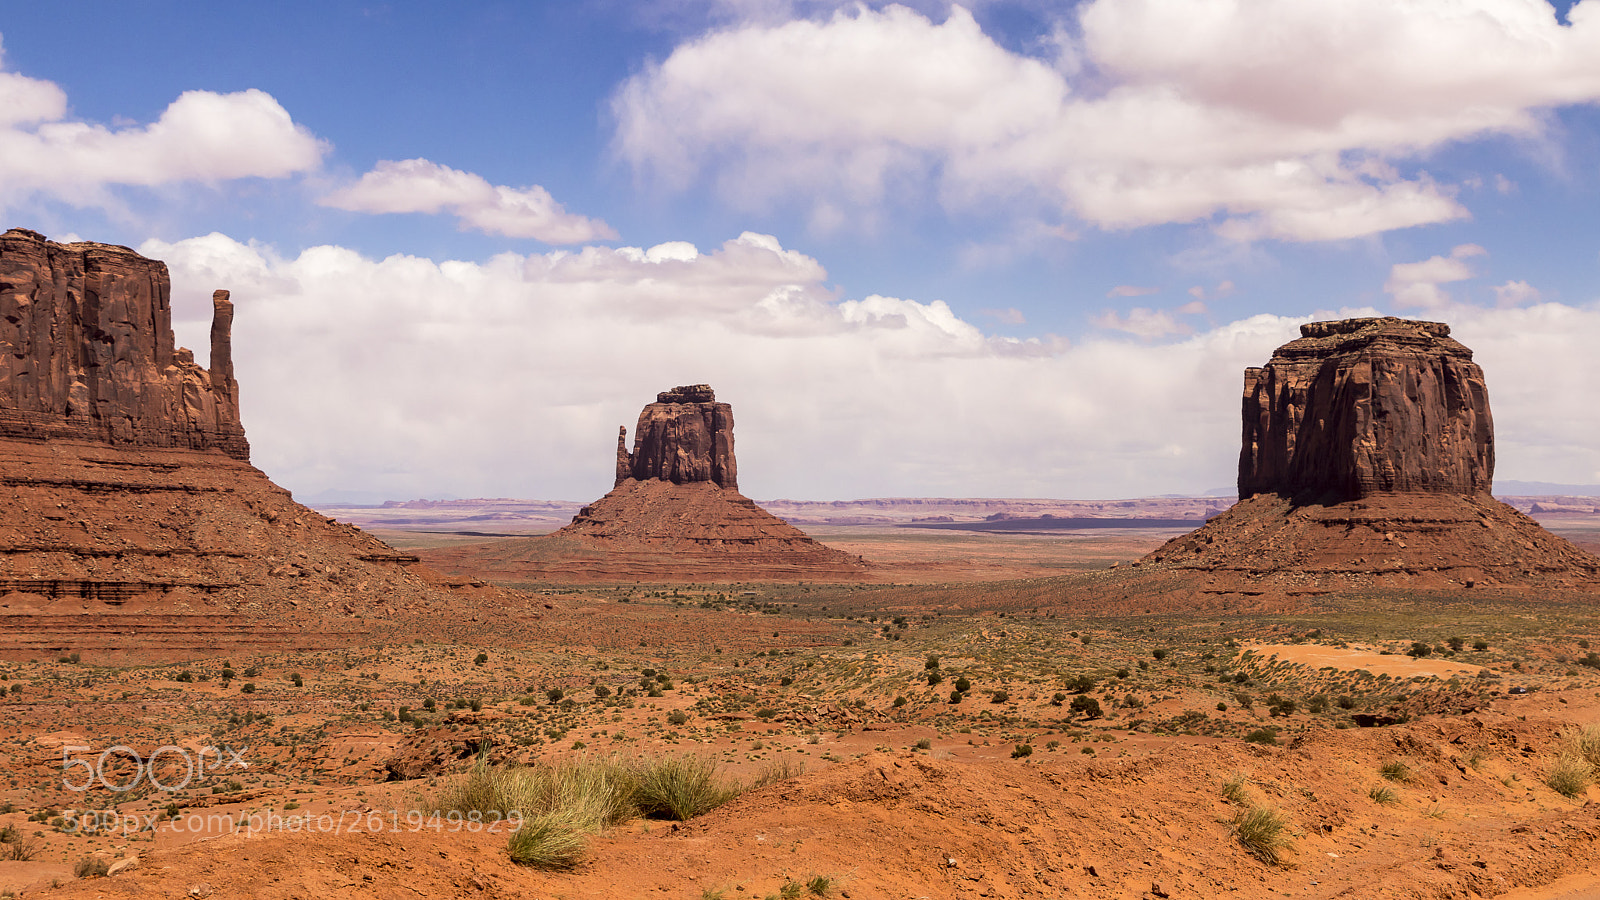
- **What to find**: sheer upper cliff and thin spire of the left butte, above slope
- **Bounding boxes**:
[0,229,250,461]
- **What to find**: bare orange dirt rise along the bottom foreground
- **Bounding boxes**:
[29,713,1600,900]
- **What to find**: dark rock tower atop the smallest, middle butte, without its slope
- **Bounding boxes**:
[614,384,739,490]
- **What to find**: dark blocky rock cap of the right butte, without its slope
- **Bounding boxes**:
[1238,317,1494,503]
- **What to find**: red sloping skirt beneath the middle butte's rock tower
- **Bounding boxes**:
[419,479,867,581]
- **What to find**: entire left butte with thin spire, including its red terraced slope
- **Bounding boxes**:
[0,229,534,658]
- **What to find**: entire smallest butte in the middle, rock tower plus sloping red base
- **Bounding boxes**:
[422,384,867,581]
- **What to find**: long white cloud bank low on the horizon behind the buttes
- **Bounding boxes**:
[141,234,1600,500]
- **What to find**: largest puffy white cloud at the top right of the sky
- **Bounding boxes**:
[611,0,1600,240]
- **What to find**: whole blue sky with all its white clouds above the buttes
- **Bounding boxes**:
[0,0,1600,500]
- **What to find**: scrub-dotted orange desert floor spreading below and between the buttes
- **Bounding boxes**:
[0,511,1600,898]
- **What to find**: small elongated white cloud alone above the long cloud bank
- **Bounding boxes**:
[318,159,616,243]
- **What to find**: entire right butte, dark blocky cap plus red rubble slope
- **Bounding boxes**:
[1134,317,1600,599]
